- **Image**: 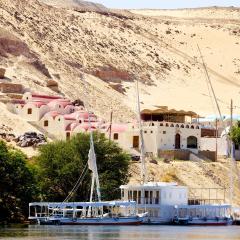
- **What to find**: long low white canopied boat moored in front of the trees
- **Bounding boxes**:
[29,201,145,225]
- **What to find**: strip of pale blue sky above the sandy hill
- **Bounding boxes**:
[92,0,240,9]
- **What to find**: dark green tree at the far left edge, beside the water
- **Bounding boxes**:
[0,141,37,222]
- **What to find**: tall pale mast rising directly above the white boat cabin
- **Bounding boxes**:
[137,80,147,183]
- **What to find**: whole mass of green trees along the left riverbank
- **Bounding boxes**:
[0,133,130,222]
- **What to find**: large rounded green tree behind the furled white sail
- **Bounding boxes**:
[36,132,130,201]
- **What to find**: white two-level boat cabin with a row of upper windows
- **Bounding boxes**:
[120,182,188,223]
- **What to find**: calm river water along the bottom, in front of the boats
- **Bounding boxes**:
[0,226,240,240]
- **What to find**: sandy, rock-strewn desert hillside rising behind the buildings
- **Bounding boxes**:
[0,0,240,120]
